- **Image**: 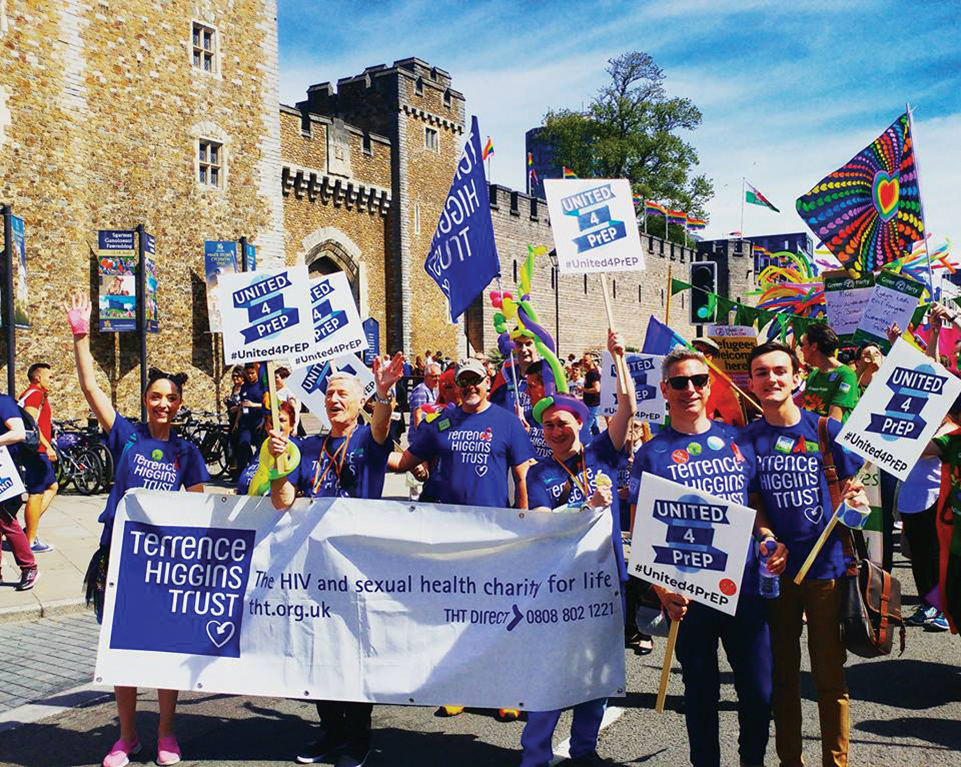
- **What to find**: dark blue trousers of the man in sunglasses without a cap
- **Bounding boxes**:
[676,594,773,767]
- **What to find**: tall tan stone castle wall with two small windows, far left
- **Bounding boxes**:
[0,0,283,416]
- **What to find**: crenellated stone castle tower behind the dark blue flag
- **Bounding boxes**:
[297,58,465,354]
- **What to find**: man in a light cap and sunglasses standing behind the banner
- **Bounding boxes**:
[397,359,533,509]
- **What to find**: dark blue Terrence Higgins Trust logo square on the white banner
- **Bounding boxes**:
[110,522,254,658]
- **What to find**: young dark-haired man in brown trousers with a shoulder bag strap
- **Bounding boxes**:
[744,341,867,767]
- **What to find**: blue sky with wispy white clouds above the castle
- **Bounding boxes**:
[278,0,961,253]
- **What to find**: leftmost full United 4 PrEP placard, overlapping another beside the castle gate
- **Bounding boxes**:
[217,266,313,365]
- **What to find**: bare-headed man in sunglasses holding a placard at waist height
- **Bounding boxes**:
[628,349,786,767]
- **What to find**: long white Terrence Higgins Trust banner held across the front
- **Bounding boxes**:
[95,490,625,711]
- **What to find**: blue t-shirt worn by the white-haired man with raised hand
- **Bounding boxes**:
[289,424,392,499]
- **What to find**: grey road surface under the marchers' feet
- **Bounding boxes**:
[0,561,961,767]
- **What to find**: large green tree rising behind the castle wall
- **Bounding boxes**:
[543,51,714,241]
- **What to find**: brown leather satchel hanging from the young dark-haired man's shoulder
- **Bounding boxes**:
[818,416,905,658]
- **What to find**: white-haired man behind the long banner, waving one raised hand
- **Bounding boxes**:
[268,352,404,767]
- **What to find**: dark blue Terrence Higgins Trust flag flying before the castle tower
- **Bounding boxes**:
[424,117,501,323]
